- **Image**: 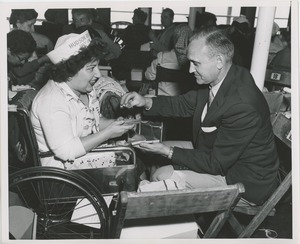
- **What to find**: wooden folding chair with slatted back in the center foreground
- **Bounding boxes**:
[110,183,244,238]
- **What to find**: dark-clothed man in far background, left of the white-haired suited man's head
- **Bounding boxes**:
[150,8,175,58]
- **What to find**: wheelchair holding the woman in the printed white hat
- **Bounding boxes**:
[8,91,137,239]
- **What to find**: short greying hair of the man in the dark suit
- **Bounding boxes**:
[190,26,234,61]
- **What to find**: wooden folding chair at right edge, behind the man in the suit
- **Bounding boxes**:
[229,113,292,238]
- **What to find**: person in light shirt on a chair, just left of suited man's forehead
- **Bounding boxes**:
[145,24,192,96]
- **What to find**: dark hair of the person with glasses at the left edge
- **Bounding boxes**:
[7,30,36,54]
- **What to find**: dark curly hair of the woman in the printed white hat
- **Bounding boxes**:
[50,38,107,82]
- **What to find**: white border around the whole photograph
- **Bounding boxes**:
[0,0,300,244]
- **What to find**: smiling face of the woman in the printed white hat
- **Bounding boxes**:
[67,61,101,96]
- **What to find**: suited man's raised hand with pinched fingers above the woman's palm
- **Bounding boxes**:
[120,92,152,108]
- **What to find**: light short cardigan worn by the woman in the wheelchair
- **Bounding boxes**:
[31,80,101,168]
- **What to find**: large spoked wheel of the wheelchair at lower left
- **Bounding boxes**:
[9,167,109,239]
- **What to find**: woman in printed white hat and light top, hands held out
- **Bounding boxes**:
[31,31,134,169]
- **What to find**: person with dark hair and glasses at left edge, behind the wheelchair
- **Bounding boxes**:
[7,29,50,90]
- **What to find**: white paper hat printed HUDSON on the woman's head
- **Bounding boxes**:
[47,30,92,64]
